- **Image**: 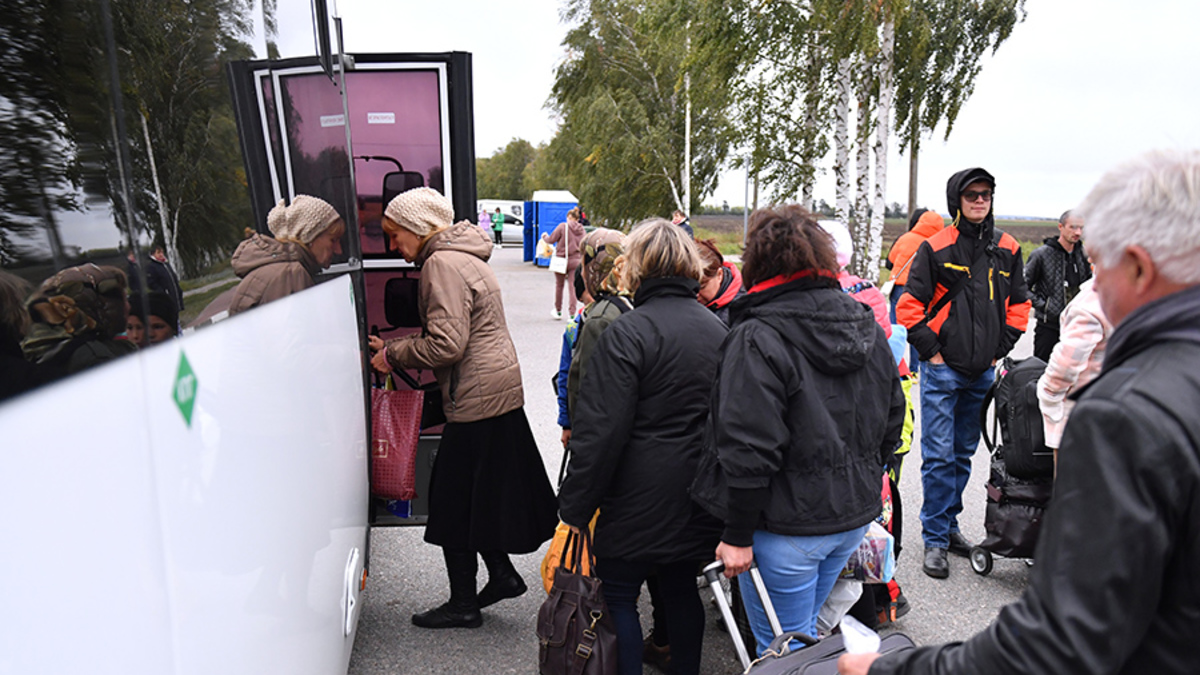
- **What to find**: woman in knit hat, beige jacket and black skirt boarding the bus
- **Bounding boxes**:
[371,187,558,628]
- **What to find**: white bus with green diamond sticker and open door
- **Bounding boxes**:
[0,1,475,675]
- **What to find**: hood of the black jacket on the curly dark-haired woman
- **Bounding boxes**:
[730,279,880,375]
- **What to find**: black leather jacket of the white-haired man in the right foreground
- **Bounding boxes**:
[870,281,1200,675]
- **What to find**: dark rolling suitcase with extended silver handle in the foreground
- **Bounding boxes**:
[704,561,916,675]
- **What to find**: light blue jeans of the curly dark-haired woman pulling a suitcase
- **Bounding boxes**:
[734,524,870,655]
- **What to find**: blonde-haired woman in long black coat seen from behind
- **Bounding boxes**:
[559,220,726,675]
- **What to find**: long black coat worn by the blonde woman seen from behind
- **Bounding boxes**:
[558,277,724,562]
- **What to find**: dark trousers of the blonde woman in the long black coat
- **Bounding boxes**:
[596,557,704,675]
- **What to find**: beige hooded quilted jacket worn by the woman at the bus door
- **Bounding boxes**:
[388,221,524,422]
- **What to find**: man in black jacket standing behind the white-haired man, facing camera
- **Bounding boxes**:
[1025,210,1092,362]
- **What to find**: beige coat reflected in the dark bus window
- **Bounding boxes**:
[229,234,320,316]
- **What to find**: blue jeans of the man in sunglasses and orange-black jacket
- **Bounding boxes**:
[920,362,996,549]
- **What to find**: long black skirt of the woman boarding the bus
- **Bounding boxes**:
[425,408,558,554]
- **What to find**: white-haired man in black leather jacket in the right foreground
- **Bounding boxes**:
[839,150,1200,675]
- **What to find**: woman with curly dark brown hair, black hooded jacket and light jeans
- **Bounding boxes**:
[694,205,905,653]
